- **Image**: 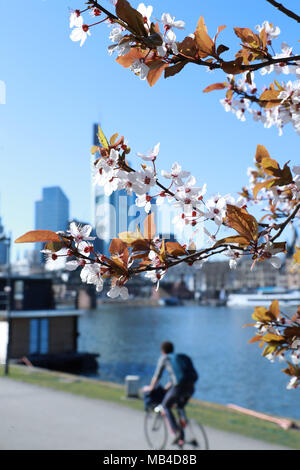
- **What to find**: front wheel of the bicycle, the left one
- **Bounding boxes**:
[144,409,168,450]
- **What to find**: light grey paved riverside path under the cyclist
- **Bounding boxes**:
[0,377,290,450]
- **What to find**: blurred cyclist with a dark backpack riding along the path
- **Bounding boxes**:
[145,341,198,444]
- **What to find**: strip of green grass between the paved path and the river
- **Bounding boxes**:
[0,365,300,449]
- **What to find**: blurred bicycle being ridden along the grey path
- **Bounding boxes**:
[144,405,209,450]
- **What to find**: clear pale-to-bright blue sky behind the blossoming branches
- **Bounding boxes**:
[0,0,300,258]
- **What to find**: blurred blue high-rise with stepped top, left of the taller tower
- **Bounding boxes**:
[35,186,69,261]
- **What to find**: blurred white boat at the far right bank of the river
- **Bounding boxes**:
[227,288,300,307]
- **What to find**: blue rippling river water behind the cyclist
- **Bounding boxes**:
[78,304,300,419]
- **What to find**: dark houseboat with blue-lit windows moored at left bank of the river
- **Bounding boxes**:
[0,276,98,373]
